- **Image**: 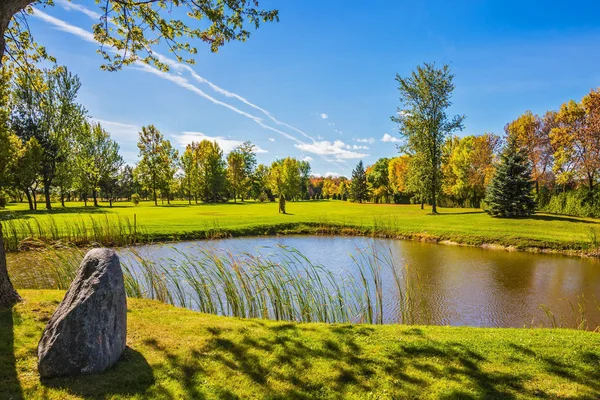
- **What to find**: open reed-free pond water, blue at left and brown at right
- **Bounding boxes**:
[119,236,600,327]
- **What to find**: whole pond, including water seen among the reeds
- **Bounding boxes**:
[8,236,600,329]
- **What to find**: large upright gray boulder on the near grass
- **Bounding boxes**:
[38,249,127,378]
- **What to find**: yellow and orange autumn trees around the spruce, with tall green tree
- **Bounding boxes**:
[350,64,600,216]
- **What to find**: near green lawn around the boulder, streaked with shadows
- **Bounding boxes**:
[0,290,600,399]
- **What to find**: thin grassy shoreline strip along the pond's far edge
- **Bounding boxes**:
[7,222,600,258]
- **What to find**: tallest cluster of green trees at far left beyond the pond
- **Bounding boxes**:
[0,67,132,210]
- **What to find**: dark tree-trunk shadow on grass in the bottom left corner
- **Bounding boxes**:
[0,308,24,400]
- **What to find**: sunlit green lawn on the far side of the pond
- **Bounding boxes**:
[0,200,600,254]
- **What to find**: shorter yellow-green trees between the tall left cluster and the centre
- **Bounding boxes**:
[139,126,311,204]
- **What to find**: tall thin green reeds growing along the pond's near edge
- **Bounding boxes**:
[10,246,432,324]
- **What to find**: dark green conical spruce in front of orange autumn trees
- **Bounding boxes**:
[485,138,535,217]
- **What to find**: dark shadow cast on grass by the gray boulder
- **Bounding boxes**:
[41,347,154,399]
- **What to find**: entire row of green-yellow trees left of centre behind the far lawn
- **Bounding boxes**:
[0,67,315,210]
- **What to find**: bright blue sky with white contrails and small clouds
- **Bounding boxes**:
[30,0,600,176]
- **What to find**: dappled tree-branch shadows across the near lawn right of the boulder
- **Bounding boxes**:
[139,324,600,399]
